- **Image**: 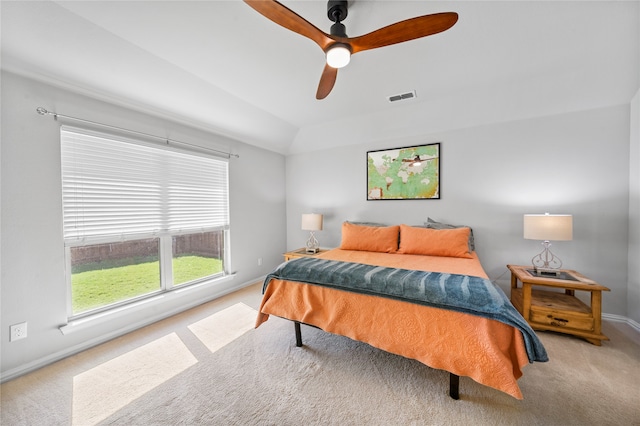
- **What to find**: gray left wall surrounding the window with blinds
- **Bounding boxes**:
[0,72,286,380]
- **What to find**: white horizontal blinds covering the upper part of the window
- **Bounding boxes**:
[61,126,229,242]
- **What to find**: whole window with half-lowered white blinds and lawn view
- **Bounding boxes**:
[61,126,229,317]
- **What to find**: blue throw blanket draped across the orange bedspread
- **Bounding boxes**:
[262,257,549,362]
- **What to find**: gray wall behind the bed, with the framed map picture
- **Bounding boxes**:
[287,105,637,316]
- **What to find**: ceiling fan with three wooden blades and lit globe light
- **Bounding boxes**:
[244,0,458,99]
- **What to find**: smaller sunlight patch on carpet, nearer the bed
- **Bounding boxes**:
[189,303,258,352]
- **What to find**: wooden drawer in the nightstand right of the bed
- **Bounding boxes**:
[529,290,594,331]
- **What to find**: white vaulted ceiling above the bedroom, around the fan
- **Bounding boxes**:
[0,0,640,154]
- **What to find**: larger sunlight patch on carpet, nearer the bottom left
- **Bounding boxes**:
[72,333,198,426]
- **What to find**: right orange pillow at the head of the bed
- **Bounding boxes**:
[398,225,473,258]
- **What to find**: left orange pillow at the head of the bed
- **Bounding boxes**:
[340,222,400,253]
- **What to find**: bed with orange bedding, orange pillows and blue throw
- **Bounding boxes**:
[256,222,548,399]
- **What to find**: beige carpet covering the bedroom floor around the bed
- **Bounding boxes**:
[0,285,640,426]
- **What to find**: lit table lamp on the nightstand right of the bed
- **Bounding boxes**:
[524,213,573,276]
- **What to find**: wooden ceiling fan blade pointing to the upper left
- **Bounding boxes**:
[244,0,334,50]
